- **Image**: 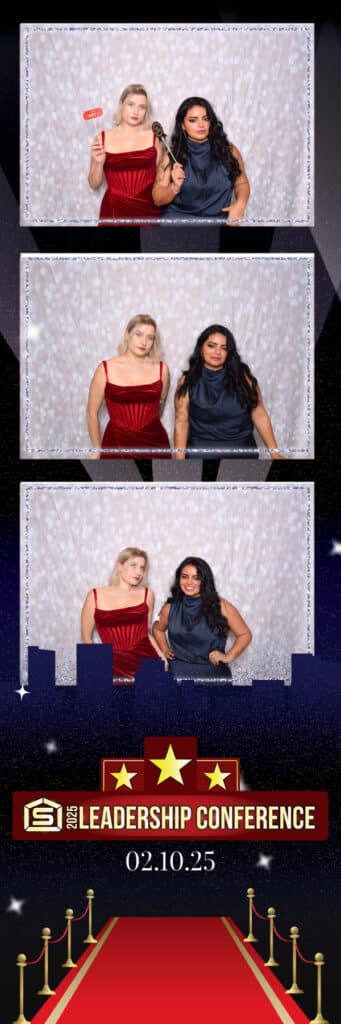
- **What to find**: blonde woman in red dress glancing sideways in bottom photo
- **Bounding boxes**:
[81,548,167,680]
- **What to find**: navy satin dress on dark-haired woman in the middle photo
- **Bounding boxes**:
[187,367,258,459]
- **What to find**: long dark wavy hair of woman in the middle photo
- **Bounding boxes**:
[176,324,259,409]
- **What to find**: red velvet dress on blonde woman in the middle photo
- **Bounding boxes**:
[100,360,171,459]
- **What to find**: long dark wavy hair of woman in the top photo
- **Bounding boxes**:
[171,96,241,185]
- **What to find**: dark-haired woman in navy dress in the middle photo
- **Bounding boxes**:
[174,324,283,479]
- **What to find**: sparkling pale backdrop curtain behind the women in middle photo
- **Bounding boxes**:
[22,255,313,458]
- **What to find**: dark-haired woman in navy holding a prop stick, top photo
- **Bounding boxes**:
[153,96,250,225]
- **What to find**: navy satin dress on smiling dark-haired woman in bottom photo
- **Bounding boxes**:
[168,595,231,680]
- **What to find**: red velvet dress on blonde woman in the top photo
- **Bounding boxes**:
[99,132,160,227]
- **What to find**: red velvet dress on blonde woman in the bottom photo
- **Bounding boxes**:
[93,587,159,679]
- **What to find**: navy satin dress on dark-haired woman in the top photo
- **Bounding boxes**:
[161,139,232,219]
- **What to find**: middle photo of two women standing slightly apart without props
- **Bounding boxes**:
[20,254,313,462]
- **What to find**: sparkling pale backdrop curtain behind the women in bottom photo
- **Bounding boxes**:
[22,483,313,682]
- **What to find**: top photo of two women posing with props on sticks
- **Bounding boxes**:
[20,24,313,230]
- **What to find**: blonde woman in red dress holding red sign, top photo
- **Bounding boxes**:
[88,84,162,227]
